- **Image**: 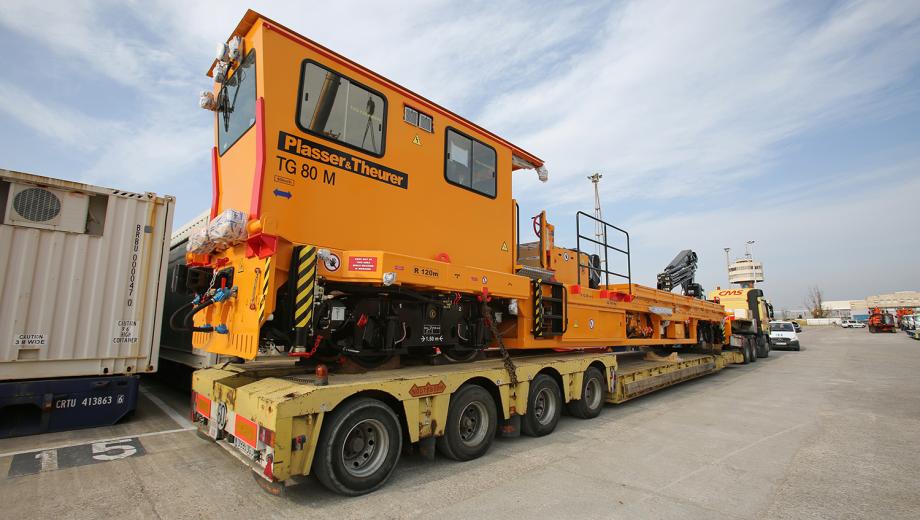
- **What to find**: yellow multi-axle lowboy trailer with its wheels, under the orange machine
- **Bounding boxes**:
[192,351,742,495]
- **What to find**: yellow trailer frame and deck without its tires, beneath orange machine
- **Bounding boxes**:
[193,350,742,492]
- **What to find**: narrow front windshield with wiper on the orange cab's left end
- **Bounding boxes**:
[217,50,256,155]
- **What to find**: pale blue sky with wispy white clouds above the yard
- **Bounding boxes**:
[0,0,920,308]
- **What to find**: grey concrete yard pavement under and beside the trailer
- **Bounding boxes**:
[0,327,920,520]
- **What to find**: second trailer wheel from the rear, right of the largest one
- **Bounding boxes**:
[437,384,498,461]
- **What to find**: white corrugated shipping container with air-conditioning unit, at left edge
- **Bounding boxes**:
[0,173,175,381]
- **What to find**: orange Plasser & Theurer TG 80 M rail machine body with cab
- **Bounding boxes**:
[189,11,725,359]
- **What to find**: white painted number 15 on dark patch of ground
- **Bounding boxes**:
[7,438,146,477]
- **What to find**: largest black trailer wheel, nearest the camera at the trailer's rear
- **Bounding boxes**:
[313,398,402,496]
